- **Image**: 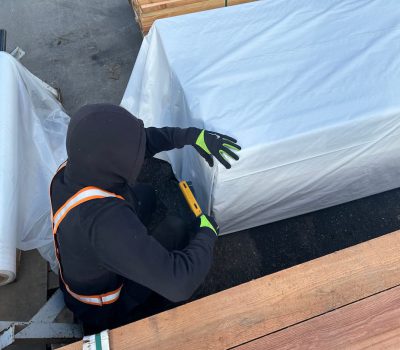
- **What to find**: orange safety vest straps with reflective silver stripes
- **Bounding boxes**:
[50,162,125,306]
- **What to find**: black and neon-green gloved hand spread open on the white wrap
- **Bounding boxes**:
[193,130,241,169]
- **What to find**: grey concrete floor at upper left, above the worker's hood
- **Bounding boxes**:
[0,0,142,114]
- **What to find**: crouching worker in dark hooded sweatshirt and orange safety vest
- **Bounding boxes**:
[50,104,240,334]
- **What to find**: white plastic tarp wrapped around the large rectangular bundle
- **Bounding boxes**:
[122,0,400,233]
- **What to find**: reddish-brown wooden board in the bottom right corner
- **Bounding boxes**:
[235,287,400,350]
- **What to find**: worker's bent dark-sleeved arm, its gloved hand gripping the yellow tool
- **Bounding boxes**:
[90,200,217,302]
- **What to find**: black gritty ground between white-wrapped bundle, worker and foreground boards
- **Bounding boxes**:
[140,159,400,298]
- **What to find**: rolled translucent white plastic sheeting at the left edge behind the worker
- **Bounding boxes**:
[0,52,69,285]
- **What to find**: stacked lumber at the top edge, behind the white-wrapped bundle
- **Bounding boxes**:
[130,0,254,35]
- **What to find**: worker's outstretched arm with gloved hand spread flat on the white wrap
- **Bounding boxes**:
[145,127,240,169]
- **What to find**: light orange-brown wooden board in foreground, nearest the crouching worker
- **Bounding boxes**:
[61,231,400,350]
